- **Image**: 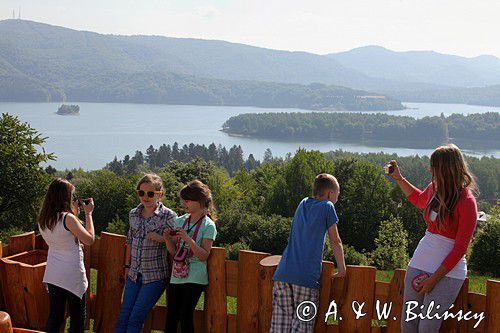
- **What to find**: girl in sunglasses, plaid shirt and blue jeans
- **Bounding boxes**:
[115,174,177,333]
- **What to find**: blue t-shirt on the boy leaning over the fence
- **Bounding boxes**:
[273,198,338,289]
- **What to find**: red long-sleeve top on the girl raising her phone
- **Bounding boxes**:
[408,183,477,272]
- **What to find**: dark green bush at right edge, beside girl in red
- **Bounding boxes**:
[469,205,500,276]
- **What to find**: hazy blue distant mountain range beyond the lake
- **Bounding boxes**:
[0,20,500,109]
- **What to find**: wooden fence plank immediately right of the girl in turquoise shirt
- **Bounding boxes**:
[204,247,227,333]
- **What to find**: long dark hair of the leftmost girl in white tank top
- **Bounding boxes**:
[37,178,78,230]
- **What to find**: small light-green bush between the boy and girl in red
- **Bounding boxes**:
[371,218,410,270]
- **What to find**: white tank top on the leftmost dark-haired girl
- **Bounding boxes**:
[38,213,88,298]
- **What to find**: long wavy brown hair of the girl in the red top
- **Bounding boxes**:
[424,143,479,230]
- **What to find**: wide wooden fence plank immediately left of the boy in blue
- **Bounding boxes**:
[236,250,269,332]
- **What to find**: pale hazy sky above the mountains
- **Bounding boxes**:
[0,0,500,57]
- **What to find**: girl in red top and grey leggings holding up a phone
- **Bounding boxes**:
[390,144,477,333]
